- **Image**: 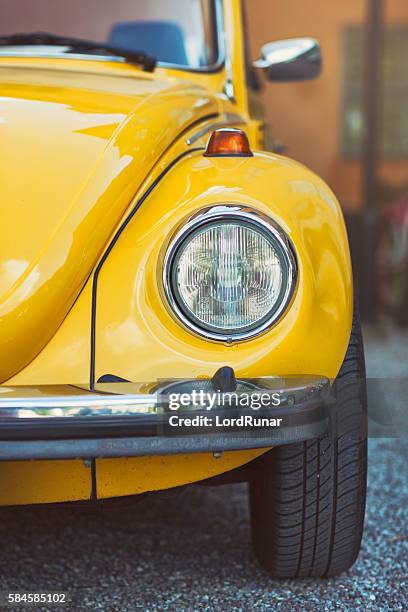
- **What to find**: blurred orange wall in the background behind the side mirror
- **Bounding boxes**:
[246,0,408,210]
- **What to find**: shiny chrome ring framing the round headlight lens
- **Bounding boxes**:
[163,203,298,343]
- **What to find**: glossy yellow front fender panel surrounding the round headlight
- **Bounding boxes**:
[92,152,352,381]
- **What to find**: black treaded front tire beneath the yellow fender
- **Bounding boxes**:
[249,313,367,578]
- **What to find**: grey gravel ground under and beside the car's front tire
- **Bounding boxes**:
[0,331,408,612]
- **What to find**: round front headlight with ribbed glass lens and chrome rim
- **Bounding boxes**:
[164,205,297,341]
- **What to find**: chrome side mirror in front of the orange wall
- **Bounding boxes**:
[254,38,322,81]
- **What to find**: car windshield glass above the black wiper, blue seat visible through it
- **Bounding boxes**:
[0,0,219,69]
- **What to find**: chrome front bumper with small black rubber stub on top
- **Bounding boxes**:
[0,367,332,460]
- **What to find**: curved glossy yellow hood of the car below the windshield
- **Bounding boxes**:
[0,58,218,381]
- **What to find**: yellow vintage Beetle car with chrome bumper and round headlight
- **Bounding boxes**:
[0,0,367,577]
